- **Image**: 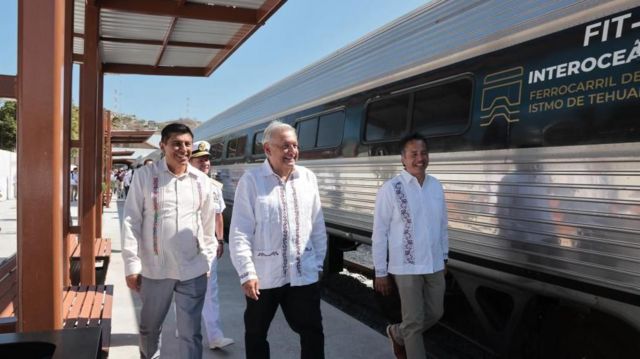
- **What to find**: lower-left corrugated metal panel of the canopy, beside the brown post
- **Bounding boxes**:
[100,41,162,65]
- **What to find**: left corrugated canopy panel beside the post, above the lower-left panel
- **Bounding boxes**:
[100,9,172,40]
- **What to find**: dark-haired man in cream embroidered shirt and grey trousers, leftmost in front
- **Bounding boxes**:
[122,123,216,359]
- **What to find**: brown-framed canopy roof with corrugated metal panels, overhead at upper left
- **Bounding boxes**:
[73,0,286,76]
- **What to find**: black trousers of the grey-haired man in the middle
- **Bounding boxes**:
[244,283,324,359]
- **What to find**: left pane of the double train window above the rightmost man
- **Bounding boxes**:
[364,94,410,141]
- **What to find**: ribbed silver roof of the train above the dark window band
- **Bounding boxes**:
[195,0,637,139]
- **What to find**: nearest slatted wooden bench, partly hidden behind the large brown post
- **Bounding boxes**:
[0,255,113,358]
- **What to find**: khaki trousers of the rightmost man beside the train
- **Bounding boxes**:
[391,271,445,359]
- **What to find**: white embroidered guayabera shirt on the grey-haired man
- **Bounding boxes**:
[229,160,327,289]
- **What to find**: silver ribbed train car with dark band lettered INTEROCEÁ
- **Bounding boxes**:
[195,0,640,357]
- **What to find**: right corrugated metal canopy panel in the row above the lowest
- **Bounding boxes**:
[171,19,242,44]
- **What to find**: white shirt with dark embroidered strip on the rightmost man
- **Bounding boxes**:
[371,171,449,277]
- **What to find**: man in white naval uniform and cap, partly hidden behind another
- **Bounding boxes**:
[189,141,234,349]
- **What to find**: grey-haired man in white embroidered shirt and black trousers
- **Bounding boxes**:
[229,121,327,359]
